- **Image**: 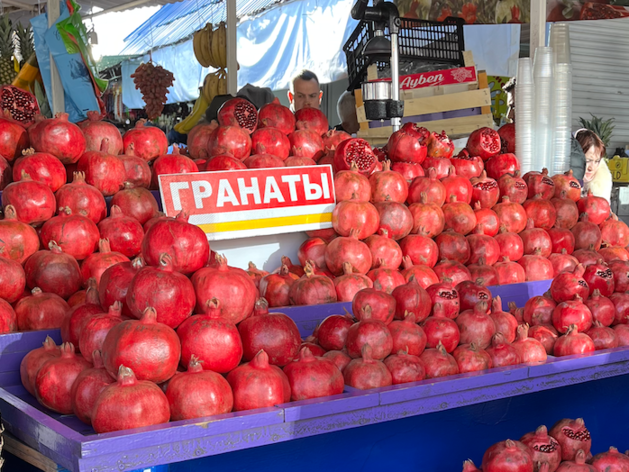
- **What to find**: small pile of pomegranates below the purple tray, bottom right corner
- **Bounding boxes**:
[463,418,629,472]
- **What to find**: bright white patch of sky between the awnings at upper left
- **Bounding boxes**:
[89,6,161,60]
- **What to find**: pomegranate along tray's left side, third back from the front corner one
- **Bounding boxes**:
[35,343,90,415]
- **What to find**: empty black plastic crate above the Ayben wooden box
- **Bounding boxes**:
[343,17,465,91]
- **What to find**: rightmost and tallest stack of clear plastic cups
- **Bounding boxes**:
[549,23,572,174]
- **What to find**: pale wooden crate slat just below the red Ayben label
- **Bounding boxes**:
[357,88,491,121]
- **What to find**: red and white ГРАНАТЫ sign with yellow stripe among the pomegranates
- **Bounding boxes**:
[159,166,336,240]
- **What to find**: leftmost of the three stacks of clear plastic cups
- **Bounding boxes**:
[514,57,535,174]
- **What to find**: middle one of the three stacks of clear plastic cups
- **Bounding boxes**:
[533,47,554,171]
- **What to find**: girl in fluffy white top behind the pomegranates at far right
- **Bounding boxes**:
[574,128,613,202]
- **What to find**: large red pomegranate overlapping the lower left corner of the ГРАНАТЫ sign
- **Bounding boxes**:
[143,209,210,275]
